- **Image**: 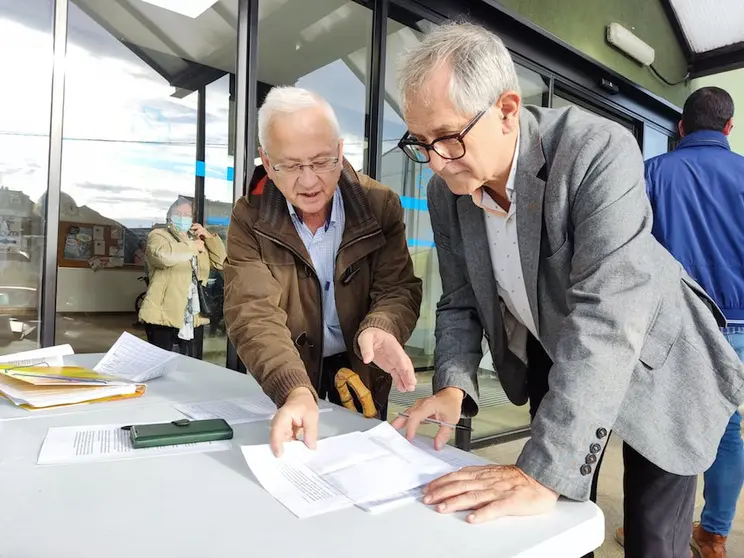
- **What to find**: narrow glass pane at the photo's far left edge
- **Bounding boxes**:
[0,0,53,354]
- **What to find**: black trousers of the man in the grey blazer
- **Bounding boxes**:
[527,336,697,558]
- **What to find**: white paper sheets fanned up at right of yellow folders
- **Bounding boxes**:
[93,331,178,383]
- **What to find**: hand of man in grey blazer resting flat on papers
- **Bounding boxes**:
[424,465,558,523]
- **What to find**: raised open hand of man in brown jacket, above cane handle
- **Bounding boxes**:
[358,327,416,391]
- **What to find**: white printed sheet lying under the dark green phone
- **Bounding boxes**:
[37,424,232,465]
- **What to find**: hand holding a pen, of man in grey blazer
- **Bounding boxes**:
[392,387,465,450]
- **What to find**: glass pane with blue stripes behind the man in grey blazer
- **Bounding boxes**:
[381,20,549,443]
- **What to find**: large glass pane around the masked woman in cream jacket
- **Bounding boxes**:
[56,0,238,358]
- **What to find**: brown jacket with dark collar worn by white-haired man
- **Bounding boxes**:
[224,161,421,410]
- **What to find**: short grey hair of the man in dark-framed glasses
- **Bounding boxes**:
[398,22,519,115]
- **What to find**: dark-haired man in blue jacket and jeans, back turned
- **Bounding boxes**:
[646,87,744,558]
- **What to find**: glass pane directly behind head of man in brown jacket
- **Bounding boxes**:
[255,0,372,170]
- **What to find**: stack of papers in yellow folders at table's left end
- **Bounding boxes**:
[0,364,145,410]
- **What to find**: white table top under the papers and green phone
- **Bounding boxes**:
[0,355,604,558]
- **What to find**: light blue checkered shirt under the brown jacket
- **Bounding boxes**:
[287,187,346,357]
